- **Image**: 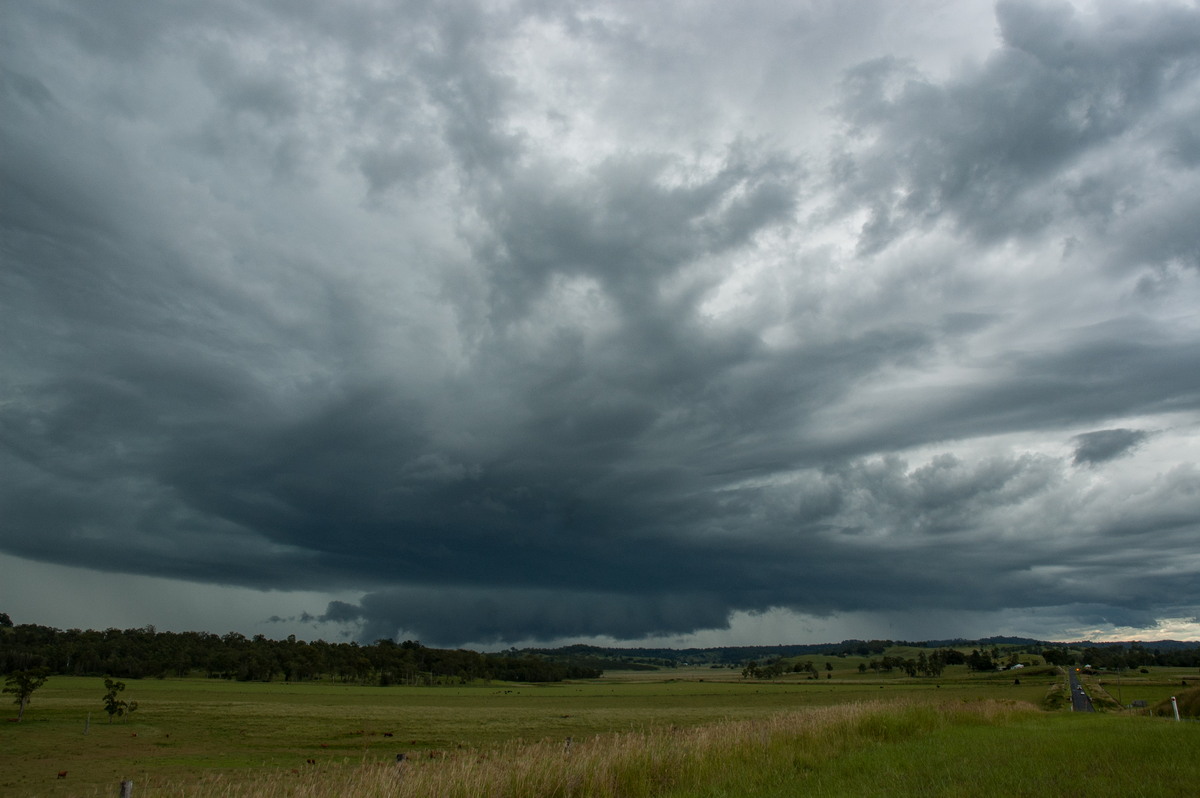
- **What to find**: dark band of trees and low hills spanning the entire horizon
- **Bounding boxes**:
[0,612,1200,684]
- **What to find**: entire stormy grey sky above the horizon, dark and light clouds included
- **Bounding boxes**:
[0,0,1200,649]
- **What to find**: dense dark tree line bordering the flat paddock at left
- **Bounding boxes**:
[0,613,602,686]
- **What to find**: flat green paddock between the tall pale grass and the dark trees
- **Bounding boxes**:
[0,668,1190,798]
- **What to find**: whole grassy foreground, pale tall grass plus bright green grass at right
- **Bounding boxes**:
[54,701,1200,798]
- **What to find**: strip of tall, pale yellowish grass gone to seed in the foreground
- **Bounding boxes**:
[100,702,1039,798]
